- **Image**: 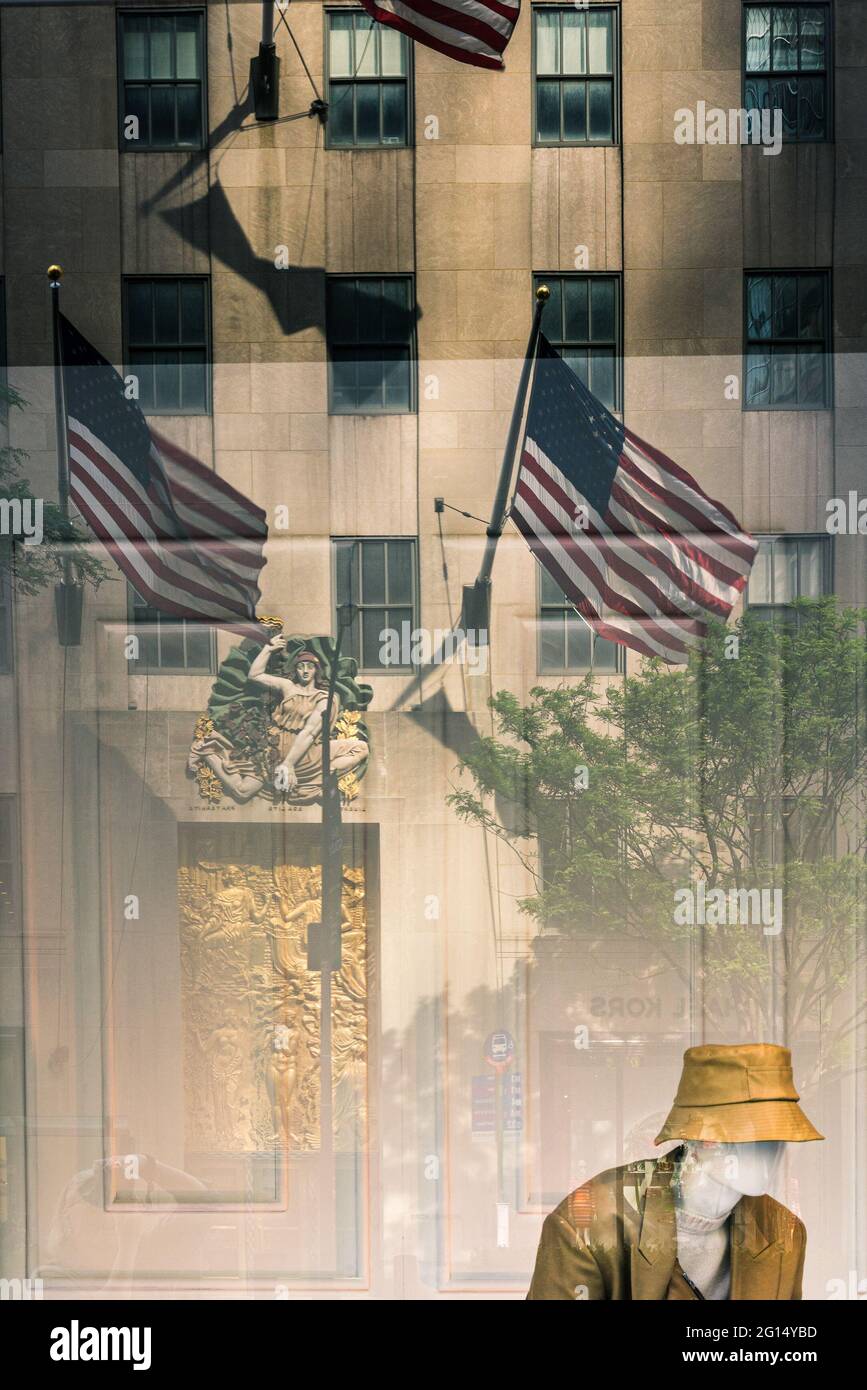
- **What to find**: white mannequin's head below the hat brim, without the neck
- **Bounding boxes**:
[677,1140,784,1215]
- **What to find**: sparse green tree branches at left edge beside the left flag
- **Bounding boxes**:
[0,382,108,595]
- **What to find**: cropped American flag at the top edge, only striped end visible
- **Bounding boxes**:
[361,0,521,68]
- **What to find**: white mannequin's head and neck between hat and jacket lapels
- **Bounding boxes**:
[671,1140,784,1300]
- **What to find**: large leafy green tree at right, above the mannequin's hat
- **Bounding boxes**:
[449,598,867,1051]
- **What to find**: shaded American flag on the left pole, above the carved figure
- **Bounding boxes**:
[60,314,268,639]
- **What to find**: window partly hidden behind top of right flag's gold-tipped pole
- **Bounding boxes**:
[534,275,622,410]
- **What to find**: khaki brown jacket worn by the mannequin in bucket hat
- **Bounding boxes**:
[527,1151,807,1301]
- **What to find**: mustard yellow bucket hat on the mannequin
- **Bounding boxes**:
[654,1043,825,1144]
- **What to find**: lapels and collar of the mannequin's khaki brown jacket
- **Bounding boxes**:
[631,1150,782,1301]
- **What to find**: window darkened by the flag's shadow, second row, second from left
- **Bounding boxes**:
[327,275,415,416]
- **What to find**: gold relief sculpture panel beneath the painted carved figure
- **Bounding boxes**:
[178,859,367,1154]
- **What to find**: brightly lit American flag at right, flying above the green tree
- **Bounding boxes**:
[511,336,757,663]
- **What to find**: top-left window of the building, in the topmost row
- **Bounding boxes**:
[118,10,206,152]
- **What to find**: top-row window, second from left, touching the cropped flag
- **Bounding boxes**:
[327,10,410,149]
